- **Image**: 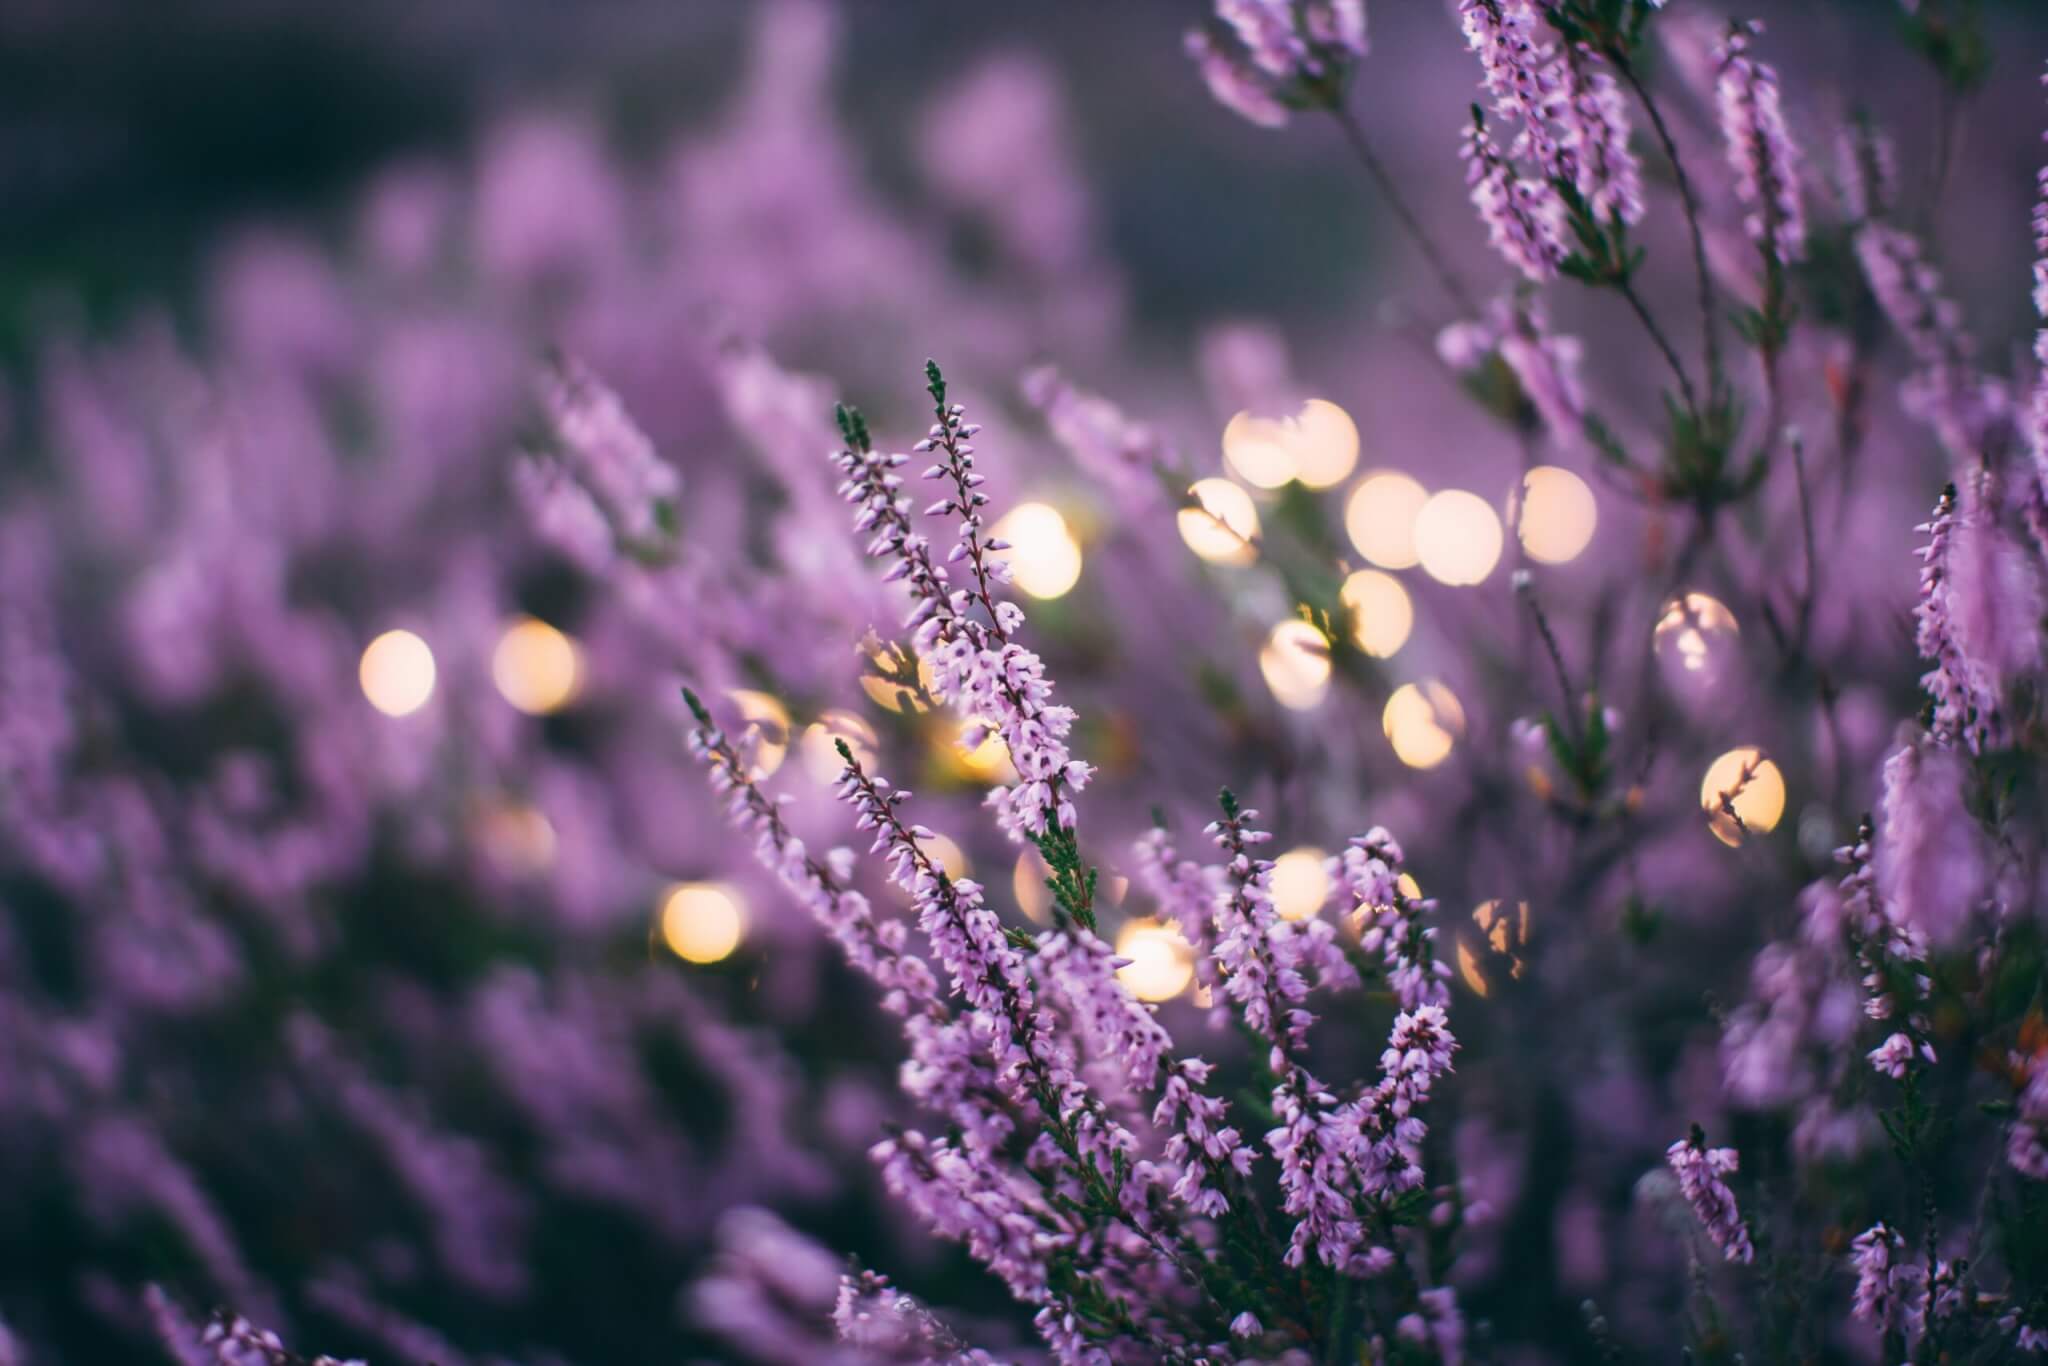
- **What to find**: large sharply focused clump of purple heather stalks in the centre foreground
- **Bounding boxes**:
[690,367,1462,1362]
